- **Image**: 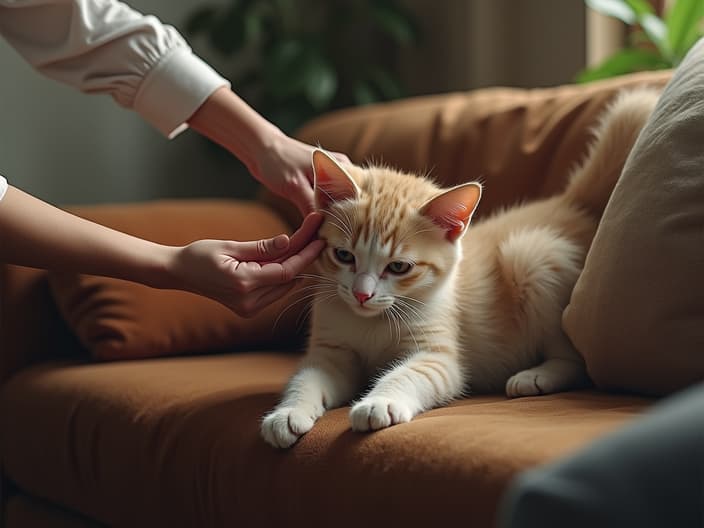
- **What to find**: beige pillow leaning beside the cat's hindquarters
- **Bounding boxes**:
[563,42,704,394]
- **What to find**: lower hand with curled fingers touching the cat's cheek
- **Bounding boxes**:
[169,213,325,317]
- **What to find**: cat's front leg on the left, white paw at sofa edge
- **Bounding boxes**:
[261,347,361,448]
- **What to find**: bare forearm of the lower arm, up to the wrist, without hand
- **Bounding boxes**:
[0,186,177,288]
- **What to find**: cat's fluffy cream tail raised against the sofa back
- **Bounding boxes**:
[564,88,660,217]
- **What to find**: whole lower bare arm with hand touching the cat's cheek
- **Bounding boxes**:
[0,186,324,316]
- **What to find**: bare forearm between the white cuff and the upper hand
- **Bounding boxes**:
[188,87,283,174]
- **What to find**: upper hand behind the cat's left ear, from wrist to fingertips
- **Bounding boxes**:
[249,131,350,215]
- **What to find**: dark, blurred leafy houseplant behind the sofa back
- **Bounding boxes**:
[186,0,419,132]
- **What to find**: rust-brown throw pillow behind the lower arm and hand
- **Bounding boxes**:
[49,200,302,360]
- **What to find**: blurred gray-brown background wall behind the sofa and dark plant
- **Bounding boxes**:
[0,0,584,204]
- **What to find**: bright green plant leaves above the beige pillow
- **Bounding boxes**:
[577,0,704,82]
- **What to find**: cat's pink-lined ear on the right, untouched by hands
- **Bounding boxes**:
[420,182,482,242]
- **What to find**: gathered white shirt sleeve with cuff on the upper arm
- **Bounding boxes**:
[0,0,229,137]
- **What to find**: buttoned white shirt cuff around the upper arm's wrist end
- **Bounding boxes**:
[134,46,230,139]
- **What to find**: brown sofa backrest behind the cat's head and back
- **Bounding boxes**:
[266,71,671,227]
